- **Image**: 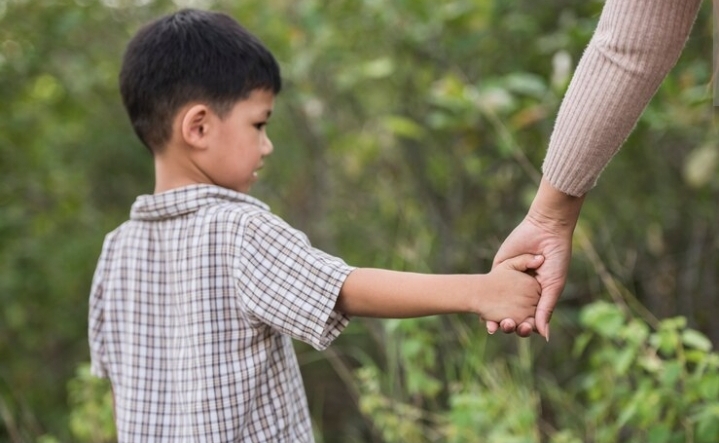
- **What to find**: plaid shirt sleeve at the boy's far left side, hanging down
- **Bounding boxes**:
[88,236,112,378]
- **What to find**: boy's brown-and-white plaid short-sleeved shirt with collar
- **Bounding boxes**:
[89,185,352,443]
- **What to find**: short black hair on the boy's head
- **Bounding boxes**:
[120,9,282,152]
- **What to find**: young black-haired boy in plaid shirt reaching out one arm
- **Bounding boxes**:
[89,10,543,443]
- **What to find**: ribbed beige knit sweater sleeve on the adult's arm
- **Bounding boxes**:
[542,0,701,196]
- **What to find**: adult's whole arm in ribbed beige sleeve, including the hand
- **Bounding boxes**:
[487,0,701,338]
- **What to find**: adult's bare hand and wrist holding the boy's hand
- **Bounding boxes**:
[487,179,584,340]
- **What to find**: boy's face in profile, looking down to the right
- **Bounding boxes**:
[207,89,275,193]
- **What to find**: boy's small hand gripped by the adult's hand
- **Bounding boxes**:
[479,254,544,324]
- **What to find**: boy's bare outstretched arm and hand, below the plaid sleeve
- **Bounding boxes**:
[335,254,544,323]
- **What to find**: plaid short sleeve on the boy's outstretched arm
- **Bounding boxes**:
[236,213,354,350]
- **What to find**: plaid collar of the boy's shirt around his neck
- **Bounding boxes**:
[130,184,269,221]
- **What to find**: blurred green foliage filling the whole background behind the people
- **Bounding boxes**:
[0,0,719,443]
